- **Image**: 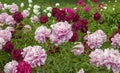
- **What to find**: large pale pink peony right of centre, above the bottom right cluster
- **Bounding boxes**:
[84,30,107,49]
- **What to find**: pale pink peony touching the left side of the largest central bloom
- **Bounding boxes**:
[35,26,51,43]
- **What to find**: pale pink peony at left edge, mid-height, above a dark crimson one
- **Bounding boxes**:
[0,30,12,42]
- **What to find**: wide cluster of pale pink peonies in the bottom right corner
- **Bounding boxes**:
[89,48,120,73]
